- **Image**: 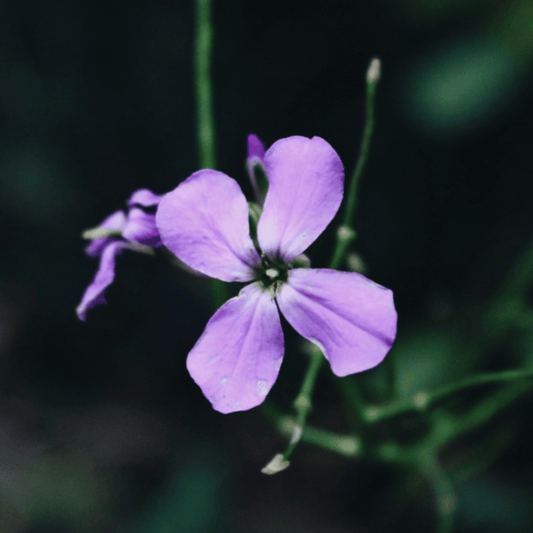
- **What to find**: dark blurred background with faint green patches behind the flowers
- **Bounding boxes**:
[0,0,533,533]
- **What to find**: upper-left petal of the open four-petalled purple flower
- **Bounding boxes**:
[156,170,260,281]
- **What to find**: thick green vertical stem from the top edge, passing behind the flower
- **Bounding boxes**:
[194,0,228,307]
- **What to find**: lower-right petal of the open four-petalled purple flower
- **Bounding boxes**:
[276,268,397,376]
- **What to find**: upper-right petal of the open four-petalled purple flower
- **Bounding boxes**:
[257,136,344,262]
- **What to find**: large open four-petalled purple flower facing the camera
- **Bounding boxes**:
[156,137,397,413]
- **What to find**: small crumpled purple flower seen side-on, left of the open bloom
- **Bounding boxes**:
[76,189,162,321]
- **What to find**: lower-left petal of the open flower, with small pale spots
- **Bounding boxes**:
[187,283,284,413]
